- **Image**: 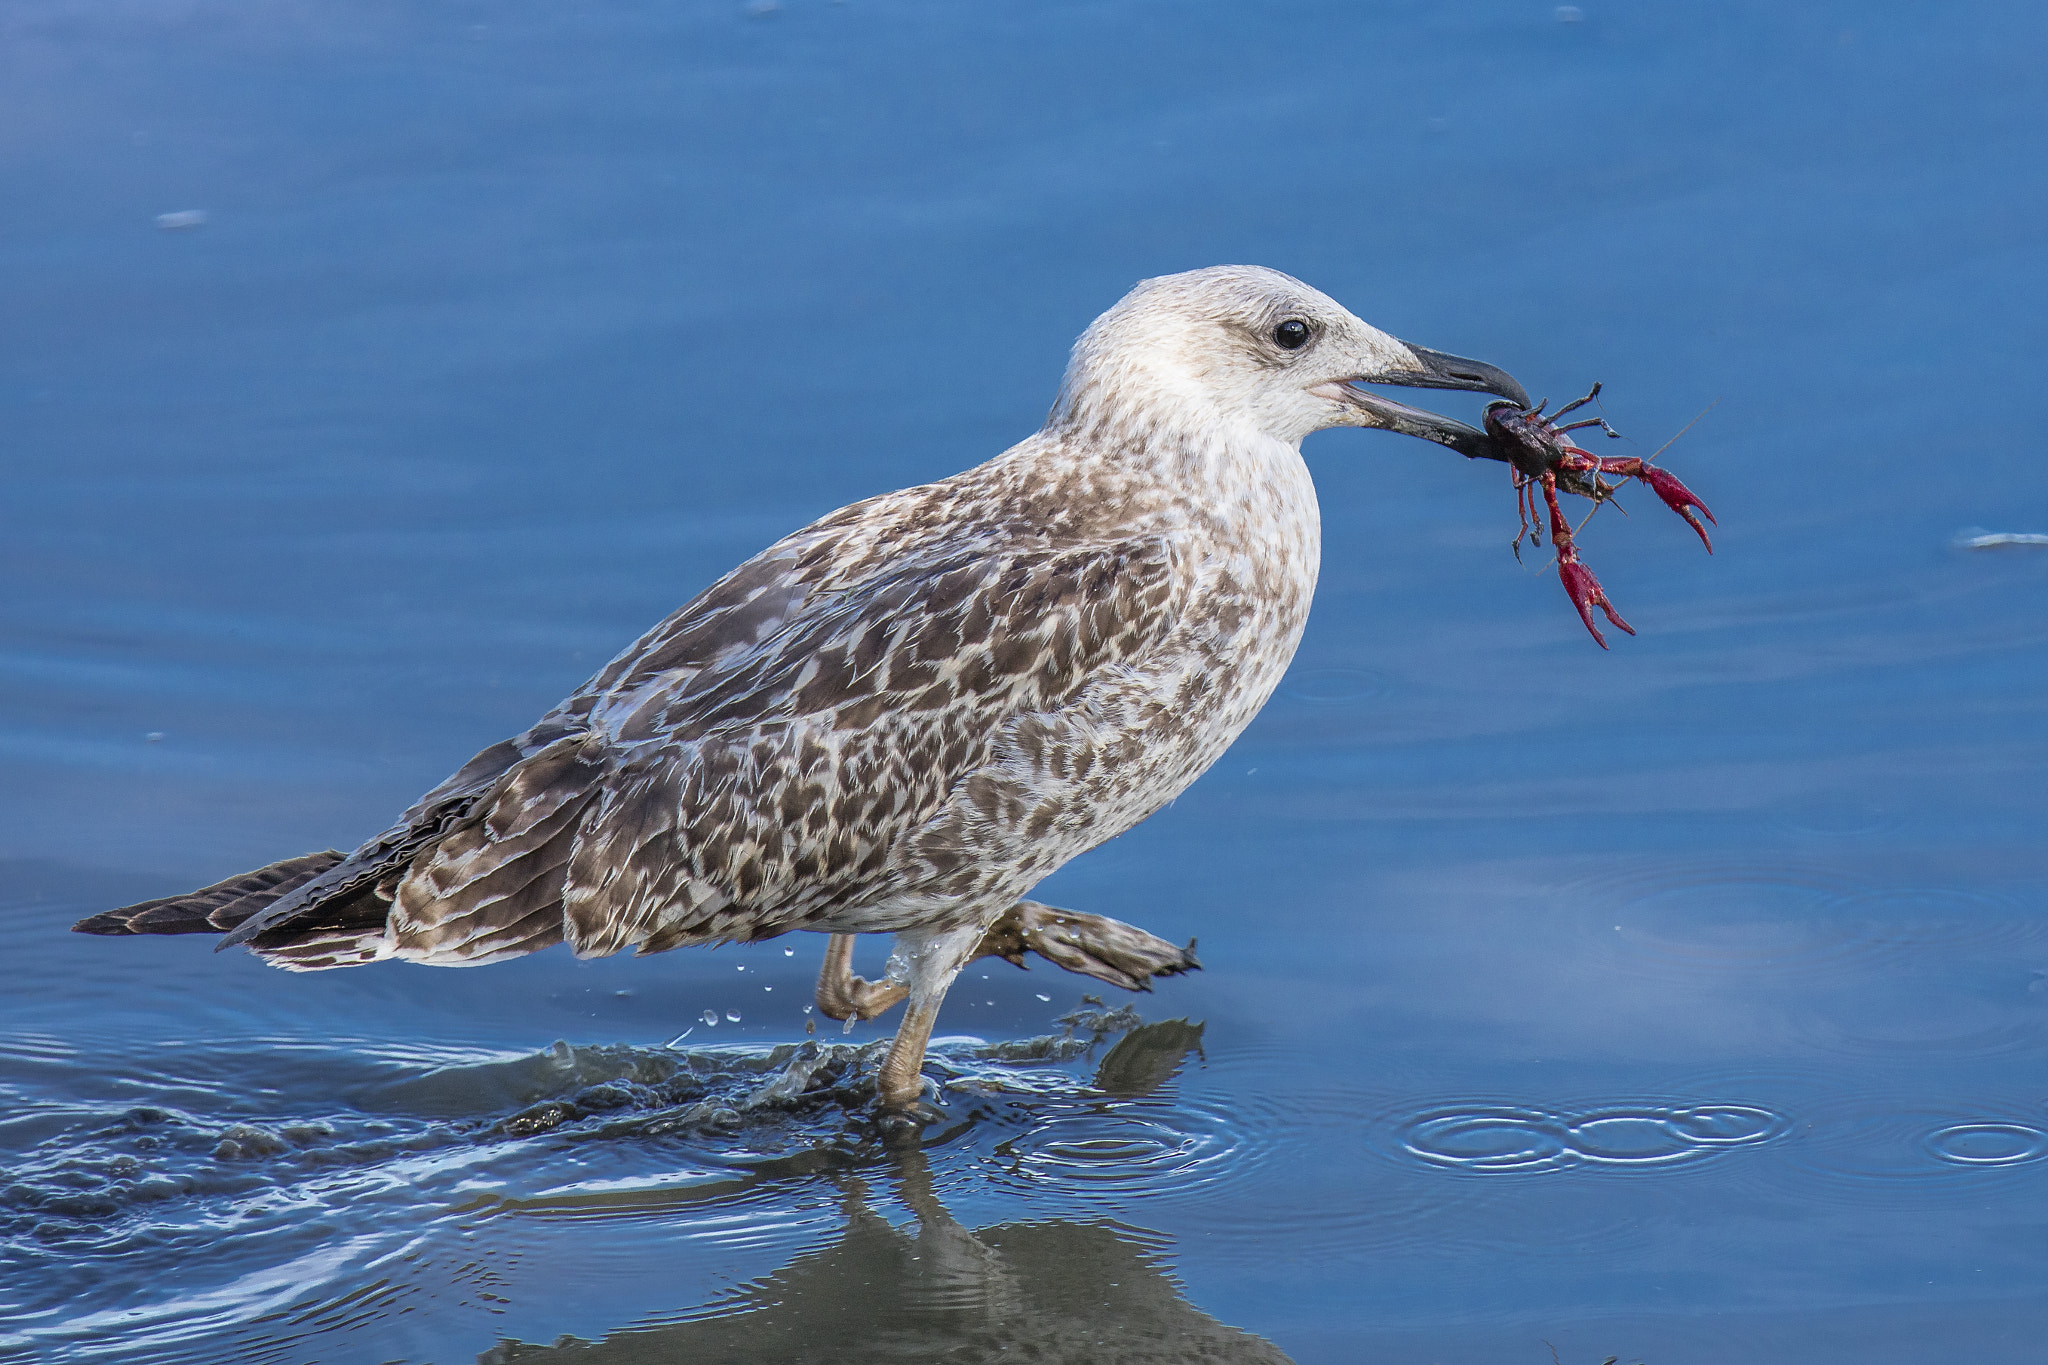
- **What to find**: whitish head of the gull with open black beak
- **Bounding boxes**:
[1047,266,1528,454]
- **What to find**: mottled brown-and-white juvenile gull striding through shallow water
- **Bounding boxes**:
[78,266,1528,1111]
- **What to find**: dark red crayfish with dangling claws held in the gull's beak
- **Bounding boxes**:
[1487,385,1718,649]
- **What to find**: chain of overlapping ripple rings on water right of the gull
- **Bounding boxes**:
[1399,1103,1788,1175]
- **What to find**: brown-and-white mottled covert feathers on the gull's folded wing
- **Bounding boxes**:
[563,538,1178,954]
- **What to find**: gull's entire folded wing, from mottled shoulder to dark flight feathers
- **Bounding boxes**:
[227,523,1178,964]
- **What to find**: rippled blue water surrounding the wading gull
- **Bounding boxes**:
[0,0,2048,1365]
